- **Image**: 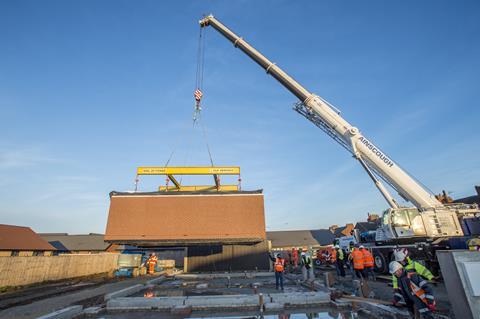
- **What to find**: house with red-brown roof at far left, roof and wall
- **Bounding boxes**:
[0,224,56,257]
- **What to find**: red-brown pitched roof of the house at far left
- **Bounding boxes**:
[0,224,55,250]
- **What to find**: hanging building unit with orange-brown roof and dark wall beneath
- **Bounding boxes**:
[105,190,269,271]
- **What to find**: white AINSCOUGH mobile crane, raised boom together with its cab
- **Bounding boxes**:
[199,15,480,271]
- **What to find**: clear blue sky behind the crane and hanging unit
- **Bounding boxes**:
[0,1,480,233]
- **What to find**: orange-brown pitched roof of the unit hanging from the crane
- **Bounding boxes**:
[105,191,265,245]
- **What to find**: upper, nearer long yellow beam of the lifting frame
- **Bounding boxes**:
[137,166,240,175]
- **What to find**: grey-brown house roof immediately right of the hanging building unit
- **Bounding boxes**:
[267,229,334,248]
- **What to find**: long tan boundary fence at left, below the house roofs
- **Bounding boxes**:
[0,253,118,287]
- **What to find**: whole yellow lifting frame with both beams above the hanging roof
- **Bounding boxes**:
[135,166,241,192]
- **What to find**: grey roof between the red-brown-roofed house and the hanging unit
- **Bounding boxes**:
[39,233,110,251]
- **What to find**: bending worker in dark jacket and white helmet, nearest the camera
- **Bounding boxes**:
[389,261,435,318]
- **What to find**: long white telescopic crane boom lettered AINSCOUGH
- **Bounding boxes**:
[199,15,443,211]
